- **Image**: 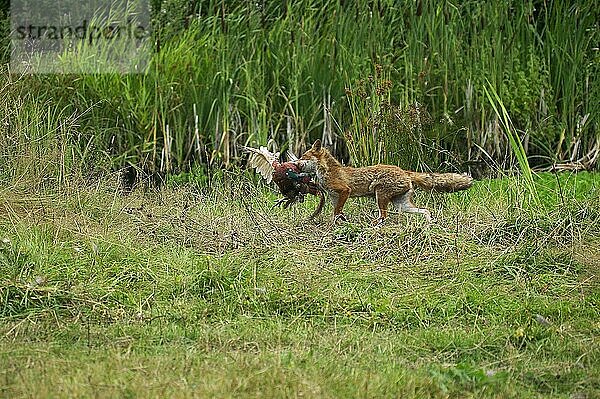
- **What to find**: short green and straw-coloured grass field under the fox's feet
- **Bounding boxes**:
[0,173,600,398]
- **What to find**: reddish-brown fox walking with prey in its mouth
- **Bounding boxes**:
[300,140,473,224]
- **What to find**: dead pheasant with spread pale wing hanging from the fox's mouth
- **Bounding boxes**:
[242,146,325,219]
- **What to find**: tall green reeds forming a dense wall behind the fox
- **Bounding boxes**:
[2,0,600,177]
